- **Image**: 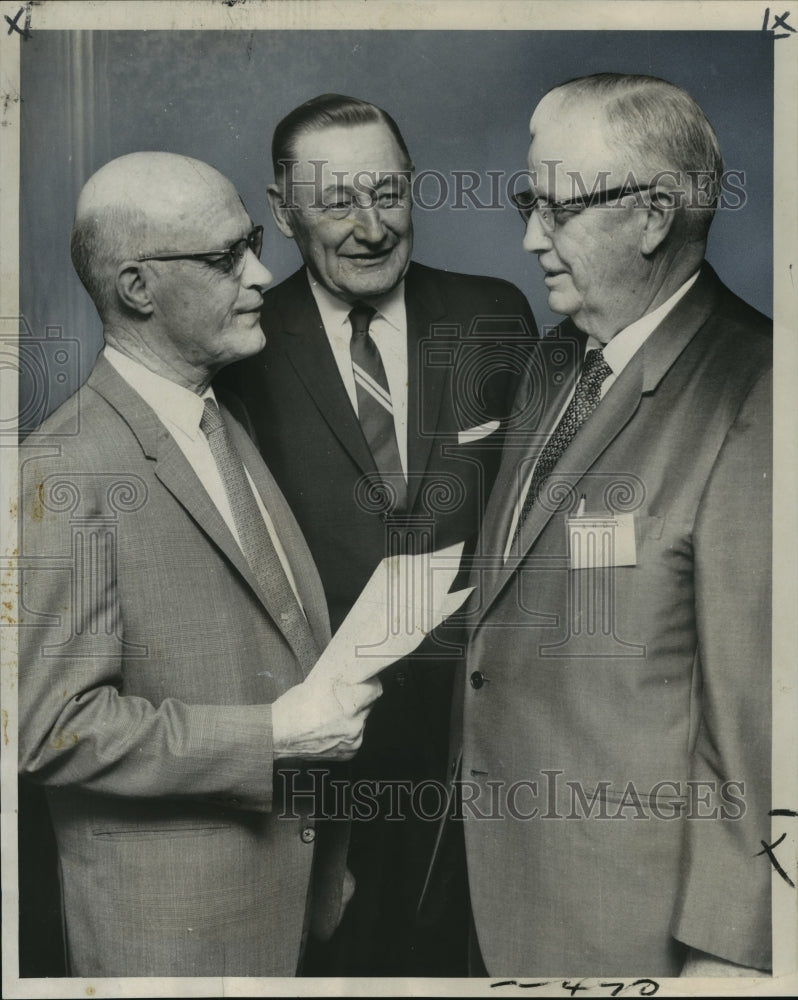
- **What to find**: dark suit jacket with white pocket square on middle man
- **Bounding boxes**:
[220,263,535,975]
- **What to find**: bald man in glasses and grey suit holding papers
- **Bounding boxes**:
[19,153,379,977]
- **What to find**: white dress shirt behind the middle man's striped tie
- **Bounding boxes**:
[307,271,408,479]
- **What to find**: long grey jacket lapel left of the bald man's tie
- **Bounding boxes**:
[88,355,322,660]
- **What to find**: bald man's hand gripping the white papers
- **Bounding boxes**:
[272,677,382,760]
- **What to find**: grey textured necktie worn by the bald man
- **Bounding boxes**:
[200,399,319,670]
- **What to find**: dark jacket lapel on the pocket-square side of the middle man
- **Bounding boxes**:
[405,264,452,510]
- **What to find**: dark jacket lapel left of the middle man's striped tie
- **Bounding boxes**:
[272,270,377,472]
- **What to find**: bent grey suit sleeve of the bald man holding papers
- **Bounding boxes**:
[18,446,273,812]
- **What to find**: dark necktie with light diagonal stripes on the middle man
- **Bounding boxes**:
[349,302,407,510]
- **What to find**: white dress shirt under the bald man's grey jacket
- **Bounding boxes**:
[104,344,302,607]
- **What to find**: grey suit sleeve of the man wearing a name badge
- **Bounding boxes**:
[674,374,772,969]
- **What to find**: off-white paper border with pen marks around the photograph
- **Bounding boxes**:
[0,0,798,998]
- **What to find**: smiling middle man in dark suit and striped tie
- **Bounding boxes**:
[225,95,534,975]
